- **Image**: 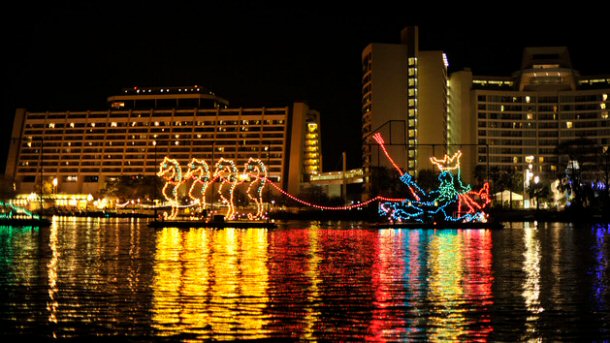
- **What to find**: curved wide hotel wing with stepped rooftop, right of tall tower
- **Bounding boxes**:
[448,47,610,185]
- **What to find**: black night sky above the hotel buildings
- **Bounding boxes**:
[0,1,610,174]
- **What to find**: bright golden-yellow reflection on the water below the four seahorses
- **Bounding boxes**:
[152,228,268,340]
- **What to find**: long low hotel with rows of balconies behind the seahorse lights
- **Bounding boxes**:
[6,86,322,195]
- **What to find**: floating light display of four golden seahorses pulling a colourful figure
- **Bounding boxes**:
[152,139,491,222]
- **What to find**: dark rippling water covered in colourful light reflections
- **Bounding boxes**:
[0,218,610,342]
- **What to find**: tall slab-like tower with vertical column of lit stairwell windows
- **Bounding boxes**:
[362,27,448,197]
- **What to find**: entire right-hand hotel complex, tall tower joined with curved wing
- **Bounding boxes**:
[362,27,610,194]
